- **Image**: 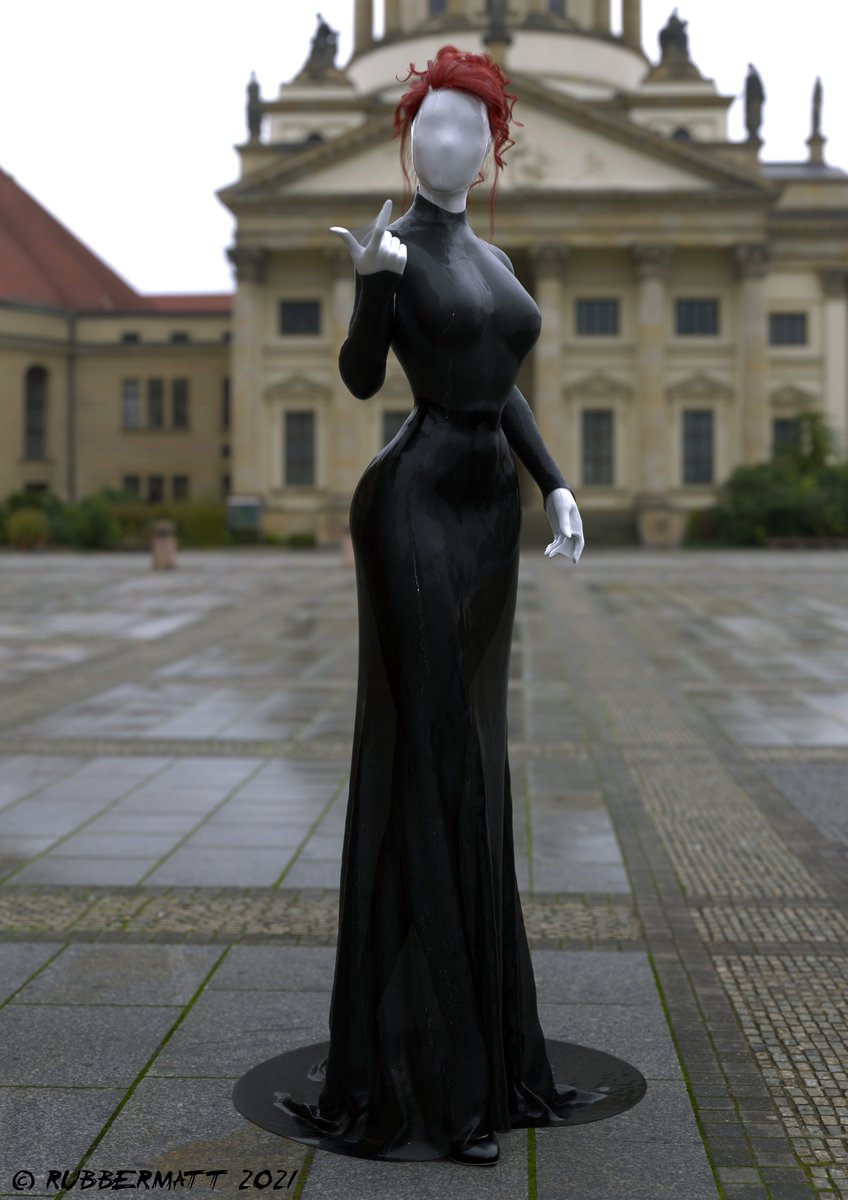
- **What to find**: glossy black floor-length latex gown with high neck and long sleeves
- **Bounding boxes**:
[277,193,596,1158]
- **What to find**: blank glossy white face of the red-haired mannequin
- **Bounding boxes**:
[410,88,492,193]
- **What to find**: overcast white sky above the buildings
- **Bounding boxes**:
[0,0,848,292]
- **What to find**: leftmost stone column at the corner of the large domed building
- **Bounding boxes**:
[228,245,267,497]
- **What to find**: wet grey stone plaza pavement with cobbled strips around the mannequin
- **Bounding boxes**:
[0,548,848,1200]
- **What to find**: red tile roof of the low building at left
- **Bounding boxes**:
[0,169,233,313]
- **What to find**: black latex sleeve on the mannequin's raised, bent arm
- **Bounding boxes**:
[338,271,402,400]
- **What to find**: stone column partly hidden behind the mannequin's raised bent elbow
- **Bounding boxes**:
[325,247,359,508]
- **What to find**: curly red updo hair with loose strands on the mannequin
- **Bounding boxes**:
[395,46,521,227]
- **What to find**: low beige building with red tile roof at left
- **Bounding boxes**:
[0,170,233,503]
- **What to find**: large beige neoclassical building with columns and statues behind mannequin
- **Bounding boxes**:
[219,0,848,540]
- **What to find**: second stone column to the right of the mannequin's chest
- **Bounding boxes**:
[633,245,673,505]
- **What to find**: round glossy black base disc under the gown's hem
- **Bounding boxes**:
[233,1038,648,1162]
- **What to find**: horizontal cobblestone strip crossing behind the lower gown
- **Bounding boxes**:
[0,886,643,950]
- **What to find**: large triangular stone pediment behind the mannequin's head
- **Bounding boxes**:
[218,79,771,205]
